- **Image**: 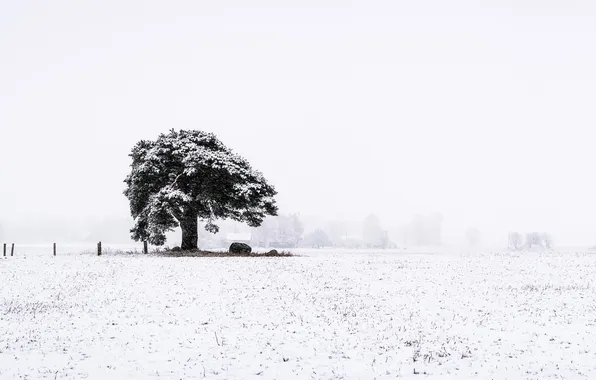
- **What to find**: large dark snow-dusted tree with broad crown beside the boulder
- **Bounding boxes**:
[124,129,277,250]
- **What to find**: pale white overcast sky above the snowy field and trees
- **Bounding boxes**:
[0,0,596,244]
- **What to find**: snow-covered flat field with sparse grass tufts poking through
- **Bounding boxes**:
[0,252,596,379]
